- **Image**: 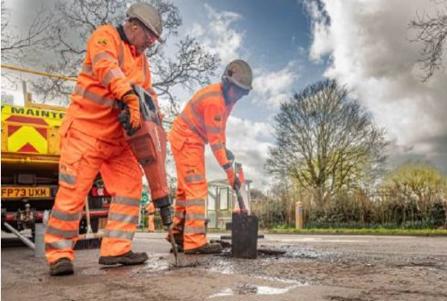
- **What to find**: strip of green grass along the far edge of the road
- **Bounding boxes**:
[266,227,447,236]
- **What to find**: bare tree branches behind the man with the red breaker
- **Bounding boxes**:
[3,0,219,113]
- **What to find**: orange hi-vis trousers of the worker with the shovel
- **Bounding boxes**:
[169,131,208,250]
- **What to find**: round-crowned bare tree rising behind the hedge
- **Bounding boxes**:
[266,80,386,209]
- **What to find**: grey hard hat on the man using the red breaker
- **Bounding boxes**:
[127,2,163,39]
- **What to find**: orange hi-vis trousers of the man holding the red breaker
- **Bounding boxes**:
[45,126,142,264]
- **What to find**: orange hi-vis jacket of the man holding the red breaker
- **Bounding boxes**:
[67,25,156,140]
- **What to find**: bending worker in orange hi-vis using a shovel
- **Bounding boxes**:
[169,60,252,254]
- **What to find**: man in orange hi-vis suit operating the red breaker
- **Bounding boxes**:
[45,3,162,276]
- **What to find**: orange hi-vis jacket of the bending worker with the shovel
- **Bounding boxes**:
[173,83,233,170]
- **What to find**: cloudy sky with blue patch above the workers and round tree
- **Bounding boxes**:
[3,0,447,190]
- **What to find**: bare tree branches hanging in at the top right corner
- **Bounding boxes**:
[410,1,447,82]
